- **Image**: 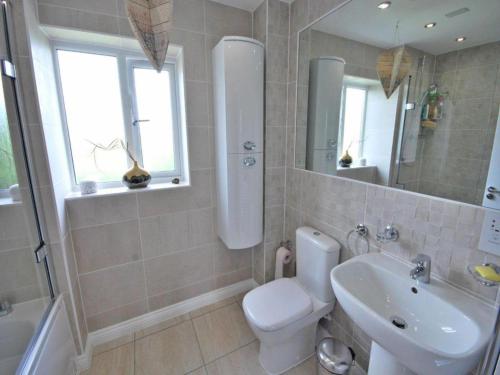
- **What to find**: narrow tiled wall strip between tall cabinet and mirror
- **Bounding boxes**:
[253,0,290,284]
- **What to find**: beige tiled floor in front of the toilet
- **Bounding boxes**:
[82,296,364,375]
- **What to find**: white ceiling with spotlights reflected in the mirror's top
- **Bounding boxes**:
[313,0,500,55]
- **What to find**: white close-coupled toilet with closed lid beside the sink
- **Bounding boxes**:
[243,227,340,375]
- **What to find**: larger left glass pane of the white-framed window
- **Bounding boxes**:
[57,50,128,183]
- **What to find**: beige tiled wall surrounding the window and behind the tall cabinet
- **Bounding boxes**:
[38,0,254,331]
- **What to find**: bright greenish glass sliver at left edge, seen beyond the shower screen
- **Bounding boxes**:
[0,78,17,189]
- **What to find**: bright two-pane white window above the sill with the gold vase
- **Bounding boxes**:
[56,46,183,184]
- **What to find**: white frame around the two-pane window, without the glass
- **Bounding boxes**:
[52,41,189,191]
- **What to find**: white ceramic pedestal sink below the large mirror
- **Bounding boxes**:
[330,253,496,375]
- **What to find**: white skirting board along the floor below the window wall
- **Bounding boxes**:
[75,279,258,372]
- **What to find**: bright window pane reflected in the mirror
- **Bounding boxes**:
[343,87,366,158]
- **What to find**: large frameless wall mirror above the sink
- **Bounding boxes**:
[295,0,500,205]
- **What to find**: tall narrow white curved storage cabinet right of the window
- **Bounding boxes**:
[212,37,264,249]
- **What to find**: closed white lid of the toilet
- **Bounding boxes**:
[243,278,313,331]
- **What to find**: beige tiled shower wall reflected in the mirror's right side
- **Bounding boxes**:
[418,42,500,204]
